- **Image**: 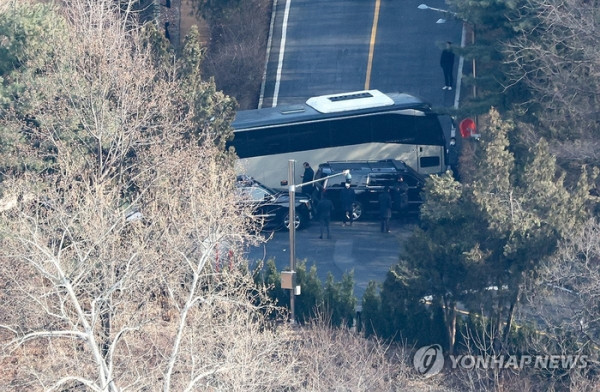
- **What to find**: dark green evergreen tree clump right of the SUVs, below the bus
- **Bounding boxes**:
[363,111,589,353]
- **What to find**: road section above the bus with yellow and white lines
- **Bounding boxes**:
[262,0,461,107]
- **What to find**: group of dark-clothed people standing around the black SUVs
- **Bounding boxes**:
[302,162,408,239]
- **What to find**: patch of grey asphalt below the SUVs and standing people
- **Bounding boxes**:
[247,220,414,300]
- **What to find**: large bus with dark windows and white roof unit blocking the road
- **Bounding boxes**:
[229,90,446,187]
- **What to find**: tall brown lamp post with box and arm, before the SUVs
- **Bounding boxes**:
[281,159,351,324]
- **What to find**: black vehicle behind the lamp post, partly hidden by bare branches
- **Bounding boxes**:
[236,176,312,230]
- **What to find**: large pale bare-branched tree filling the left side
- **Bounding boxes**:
[0,1,300,391]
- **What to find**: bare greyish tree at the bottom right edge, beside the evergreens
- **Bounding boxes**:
[523,219,600,391]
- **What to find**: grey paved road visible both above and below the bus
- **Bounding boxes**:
[248,0,462,299]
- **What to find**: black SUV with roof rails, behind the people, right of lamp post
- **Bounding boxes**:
[315,159,426,220]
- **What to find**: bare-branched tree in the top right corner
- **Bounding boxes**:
[506,0,600,150]
